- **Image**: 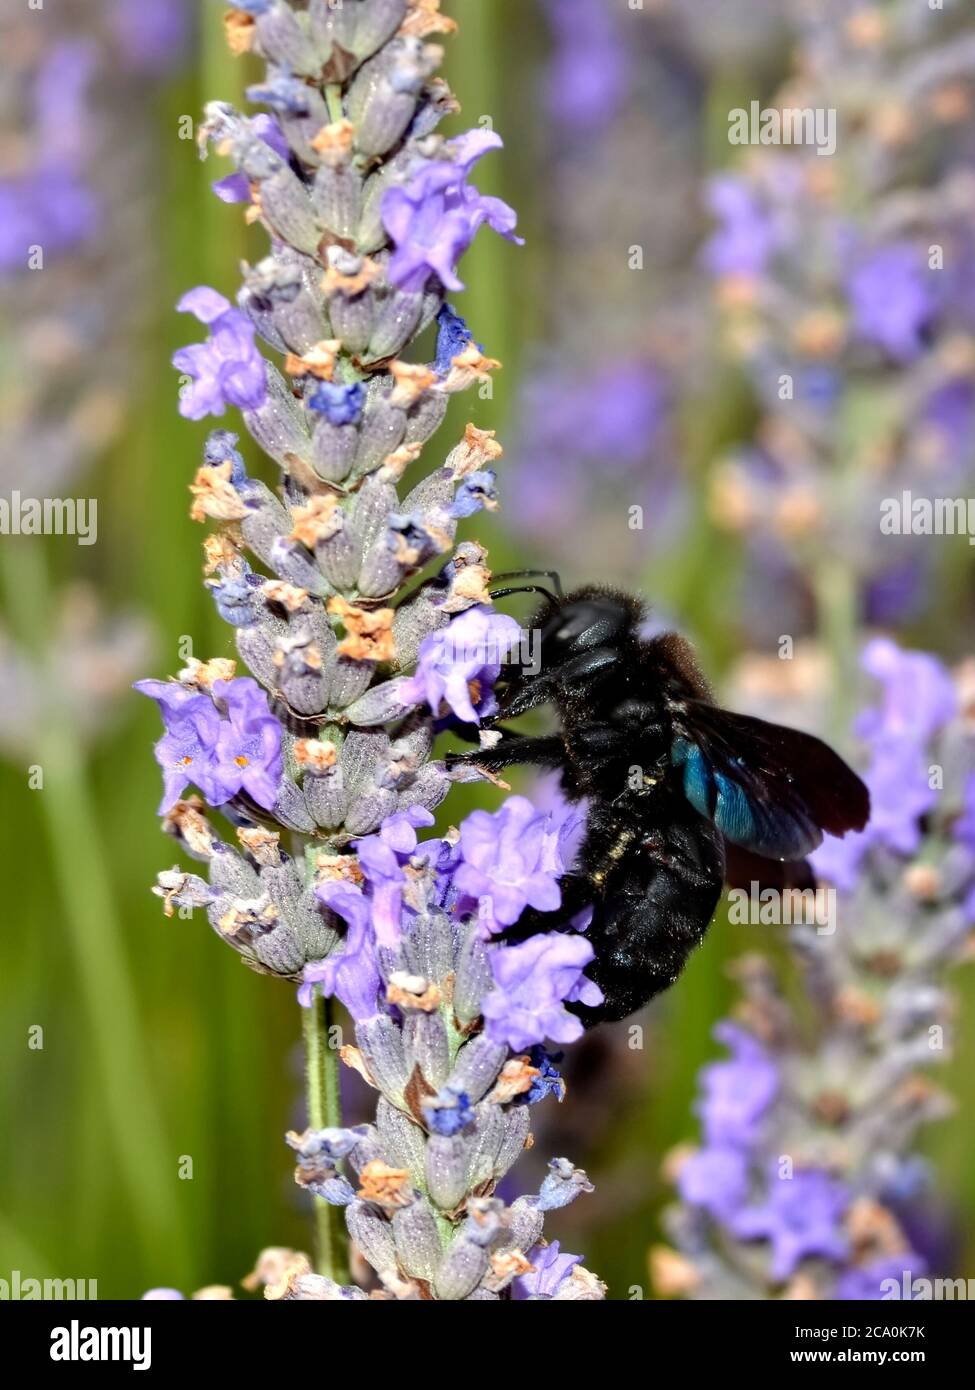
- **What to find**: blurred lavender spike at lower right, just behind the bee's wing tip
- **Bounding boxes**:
[656,639,975,1300]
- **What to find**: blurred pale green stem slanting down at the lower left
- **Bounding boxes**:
[0,539,188,1269]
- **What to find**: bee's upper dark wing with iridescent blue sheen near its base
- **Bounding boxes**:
[670,699,869,859]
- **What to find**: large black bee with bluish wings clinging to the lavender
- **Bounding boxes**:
[447,571,869,1026]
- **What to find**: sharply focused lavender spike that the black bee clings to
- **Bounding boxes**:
[138,0,605,1302]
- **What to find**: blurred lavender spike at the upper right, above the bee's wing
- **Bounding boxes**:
[701,3,975,639]
